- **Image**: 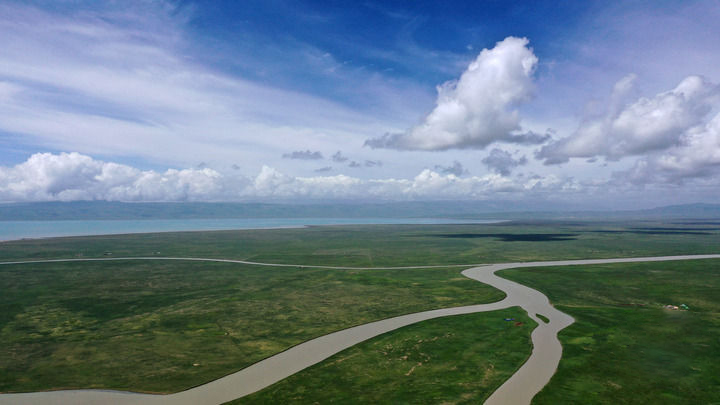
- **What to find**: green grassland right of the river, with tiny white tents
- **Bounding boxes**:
[500,260,720,404]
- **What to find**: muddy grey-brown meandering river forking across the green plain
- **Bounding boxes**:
[0,254,720,405]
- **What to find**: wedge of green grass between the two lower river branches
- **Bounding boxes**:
[230,307,535,405]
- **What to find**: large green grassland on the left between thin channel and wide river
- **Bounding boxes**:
[0,261,504,392]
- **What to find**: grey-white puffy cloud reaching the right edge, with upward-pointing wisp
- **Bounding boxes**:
[537,75,720,164]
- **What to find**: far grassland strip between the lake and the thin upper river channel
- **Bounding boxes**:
[0,221,720,267]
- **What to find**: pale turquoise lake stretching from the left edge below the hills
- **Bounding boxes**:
[0,218,499,241]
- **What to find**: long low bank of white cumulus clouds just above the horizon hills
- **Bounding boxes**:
[0,153,584,202]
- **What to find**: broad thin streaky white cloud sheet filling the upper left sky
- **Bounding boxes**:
[0,2,404,170]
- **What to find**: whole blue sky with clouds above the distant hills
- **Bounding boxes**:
[0,0,720,209]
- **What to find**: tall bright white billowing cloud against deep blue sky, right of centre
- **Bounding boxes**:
[365,37,538,150]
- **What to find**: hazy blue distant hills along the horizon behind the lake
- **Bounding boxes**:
[0,201,720,221]
